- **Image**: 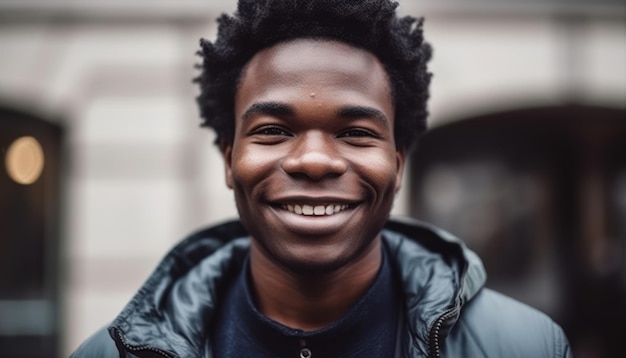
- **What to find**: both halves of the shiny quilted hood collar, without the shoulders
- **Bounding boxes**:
[109,219,486,357]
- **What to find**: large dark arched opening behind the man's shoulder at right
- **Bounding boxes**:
[410,106,626,357]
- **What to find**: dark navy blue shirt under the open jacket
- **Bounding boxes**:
[211,249,401,358]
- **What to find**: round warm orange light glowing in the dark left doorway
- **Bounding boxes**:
[6,137,44,185]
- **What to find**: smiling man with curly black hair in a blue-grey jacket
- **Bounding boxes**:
[75,0,570,358]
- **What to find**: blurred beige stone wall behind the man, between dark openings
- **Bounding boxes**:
[0,1,626,356]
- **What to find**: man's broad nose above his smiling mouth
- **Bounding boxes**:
[281,132,348,181]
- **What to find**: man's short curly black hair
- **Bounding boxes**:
[194,0,432,149]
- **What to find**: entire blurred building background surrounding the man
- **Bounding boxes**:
[0,0,626,357]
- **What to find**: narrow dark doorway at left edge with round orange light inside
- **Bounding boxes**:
[0,108,62,357]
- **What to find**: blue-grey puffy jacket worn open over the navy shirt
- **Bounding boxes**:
[73,219,571,358]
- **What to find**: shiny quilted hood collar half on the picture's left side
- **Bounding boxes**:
[109,221,249,357]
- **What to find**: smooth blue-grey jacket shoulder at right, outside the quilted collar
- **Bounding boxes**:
[446,289,571,358]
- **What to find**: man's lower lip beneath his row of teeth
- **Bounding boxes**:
[269,206,358,236]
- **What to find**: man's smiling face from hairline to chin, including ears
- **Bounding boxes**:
[224,40,405,272]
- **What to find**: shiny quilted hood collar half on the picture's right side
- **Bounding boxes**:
[383,218,487,357]
